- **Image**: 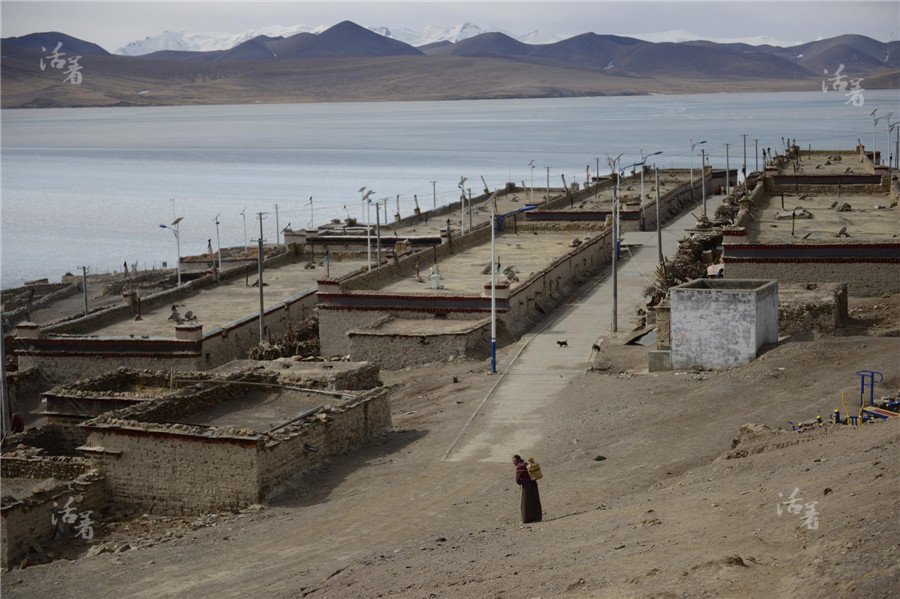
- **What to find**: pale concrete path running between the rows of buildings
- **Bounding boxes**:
[444,210,696,462]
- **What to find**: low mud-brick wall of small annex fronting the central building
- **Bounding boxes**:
[348,320,490,370]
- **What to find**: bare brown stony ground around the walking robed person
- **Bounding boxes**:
[2,288,900,599]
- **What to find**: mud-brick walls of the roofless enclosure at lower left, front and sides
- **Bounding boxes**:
[84,385,391,515]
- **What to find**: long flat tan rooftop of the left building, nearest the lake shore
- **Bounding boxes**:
[85,258,366,338]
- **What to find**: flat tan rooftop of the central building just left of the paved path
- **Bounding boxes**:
[379,229,600,295]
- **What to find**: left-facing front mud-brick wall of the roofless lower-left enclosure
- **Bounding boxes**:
[88,427,259,515]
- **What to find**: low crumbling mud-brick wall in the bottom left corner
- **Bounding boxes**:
[0,475,106,568]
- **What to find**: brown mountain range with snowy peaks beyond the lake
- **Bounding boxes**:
[2,21,900,108]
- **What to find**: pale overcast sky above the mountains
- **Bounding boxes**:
[0,0,900,52]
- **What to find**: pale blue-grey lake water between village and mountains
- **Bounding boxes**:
[0,90,900,288]
